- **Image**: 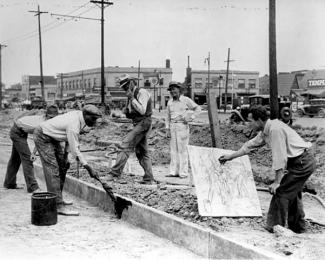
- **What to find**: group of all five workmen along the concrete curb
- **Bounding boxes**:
[4,75,316,233]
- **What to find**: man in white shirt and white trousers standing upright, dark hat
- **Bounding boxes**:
[166,81,201,178]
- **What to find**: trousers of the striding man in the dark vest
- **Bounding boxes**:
[111,117,153,180]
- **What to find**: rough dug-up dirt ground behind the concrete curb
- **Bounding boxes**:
[0,108,325,259]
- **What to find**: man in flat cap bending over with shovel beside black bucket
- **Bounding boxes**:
[34,105,101,216]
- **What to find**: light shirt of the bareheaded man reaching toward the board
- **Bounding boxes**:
[240,119,311,171]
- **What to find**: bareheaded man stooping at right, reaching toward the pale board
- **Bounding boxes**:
[219,106,316,233]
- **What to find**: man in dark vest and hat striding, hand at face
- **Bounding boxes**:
[108,74,154,184]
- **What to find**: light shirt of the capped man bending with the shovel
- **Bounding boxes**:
[40,111,87,165]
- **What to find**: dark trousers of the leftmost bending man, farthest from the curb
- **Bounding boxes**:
[3,124,38,192]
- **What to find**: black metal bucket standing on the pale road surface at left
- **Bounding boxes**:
[32,192,58,226]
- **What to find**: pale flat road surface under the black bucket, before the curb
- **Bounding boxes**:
[0,146,202,260]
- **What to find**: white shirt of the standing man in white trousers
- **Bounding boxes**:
[166,95,201,129]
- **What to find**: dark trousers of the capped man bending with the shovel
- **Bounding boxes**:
[34,127,68,204]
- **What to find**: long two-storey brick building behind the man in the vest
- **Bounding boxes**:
[57,60,172,108]
